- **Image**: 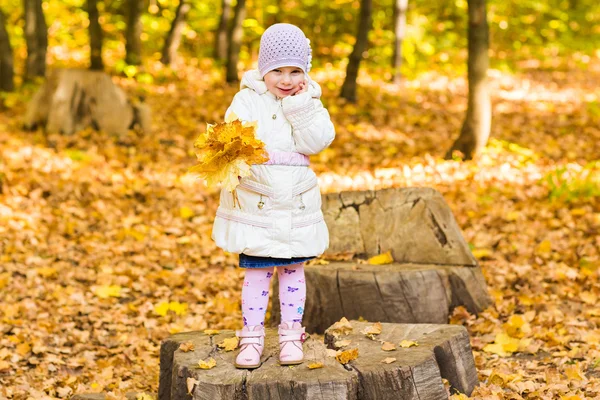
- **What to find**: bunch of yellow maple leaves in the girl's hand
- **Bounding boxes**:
[190,113,269,203]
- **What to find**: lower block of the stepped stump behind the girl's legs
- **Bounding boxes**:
[271,262,491,333]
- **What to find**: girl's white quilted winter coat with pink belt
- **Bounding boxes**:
[212,70,335,258]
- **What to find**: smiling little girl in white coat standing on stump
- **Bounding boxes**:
[212,24,335,368]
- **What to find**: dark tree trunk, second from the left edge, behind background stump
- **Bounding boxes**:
[24,0,48,80]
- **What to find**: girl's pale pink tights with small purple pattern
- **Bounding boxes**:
[242,263,306,326]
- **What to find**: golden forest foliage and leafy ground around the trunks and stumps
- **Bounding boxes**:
[0,0,600,400]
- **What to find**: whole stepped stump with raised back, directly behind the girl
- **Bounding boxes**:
[271,188,491,332]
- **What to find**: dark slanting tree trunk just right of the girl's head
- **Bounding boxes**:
[341,0,373,103]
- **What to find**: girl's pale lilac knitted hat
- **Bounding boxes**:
[258,24,312,77]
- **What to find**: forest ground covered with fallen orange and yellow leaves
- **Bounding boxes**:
[0,63,600,400]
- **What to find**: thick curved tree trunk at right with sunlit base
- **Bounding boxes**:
[446,0,492,160]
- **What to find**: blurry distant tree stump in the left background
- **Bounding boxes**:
[24,69,150,135]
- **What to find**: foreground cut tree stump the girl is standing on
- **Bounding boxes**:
[158,321,477,400]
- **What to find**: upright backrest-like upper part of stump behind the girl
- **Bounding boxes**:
[322,188,477,266]
